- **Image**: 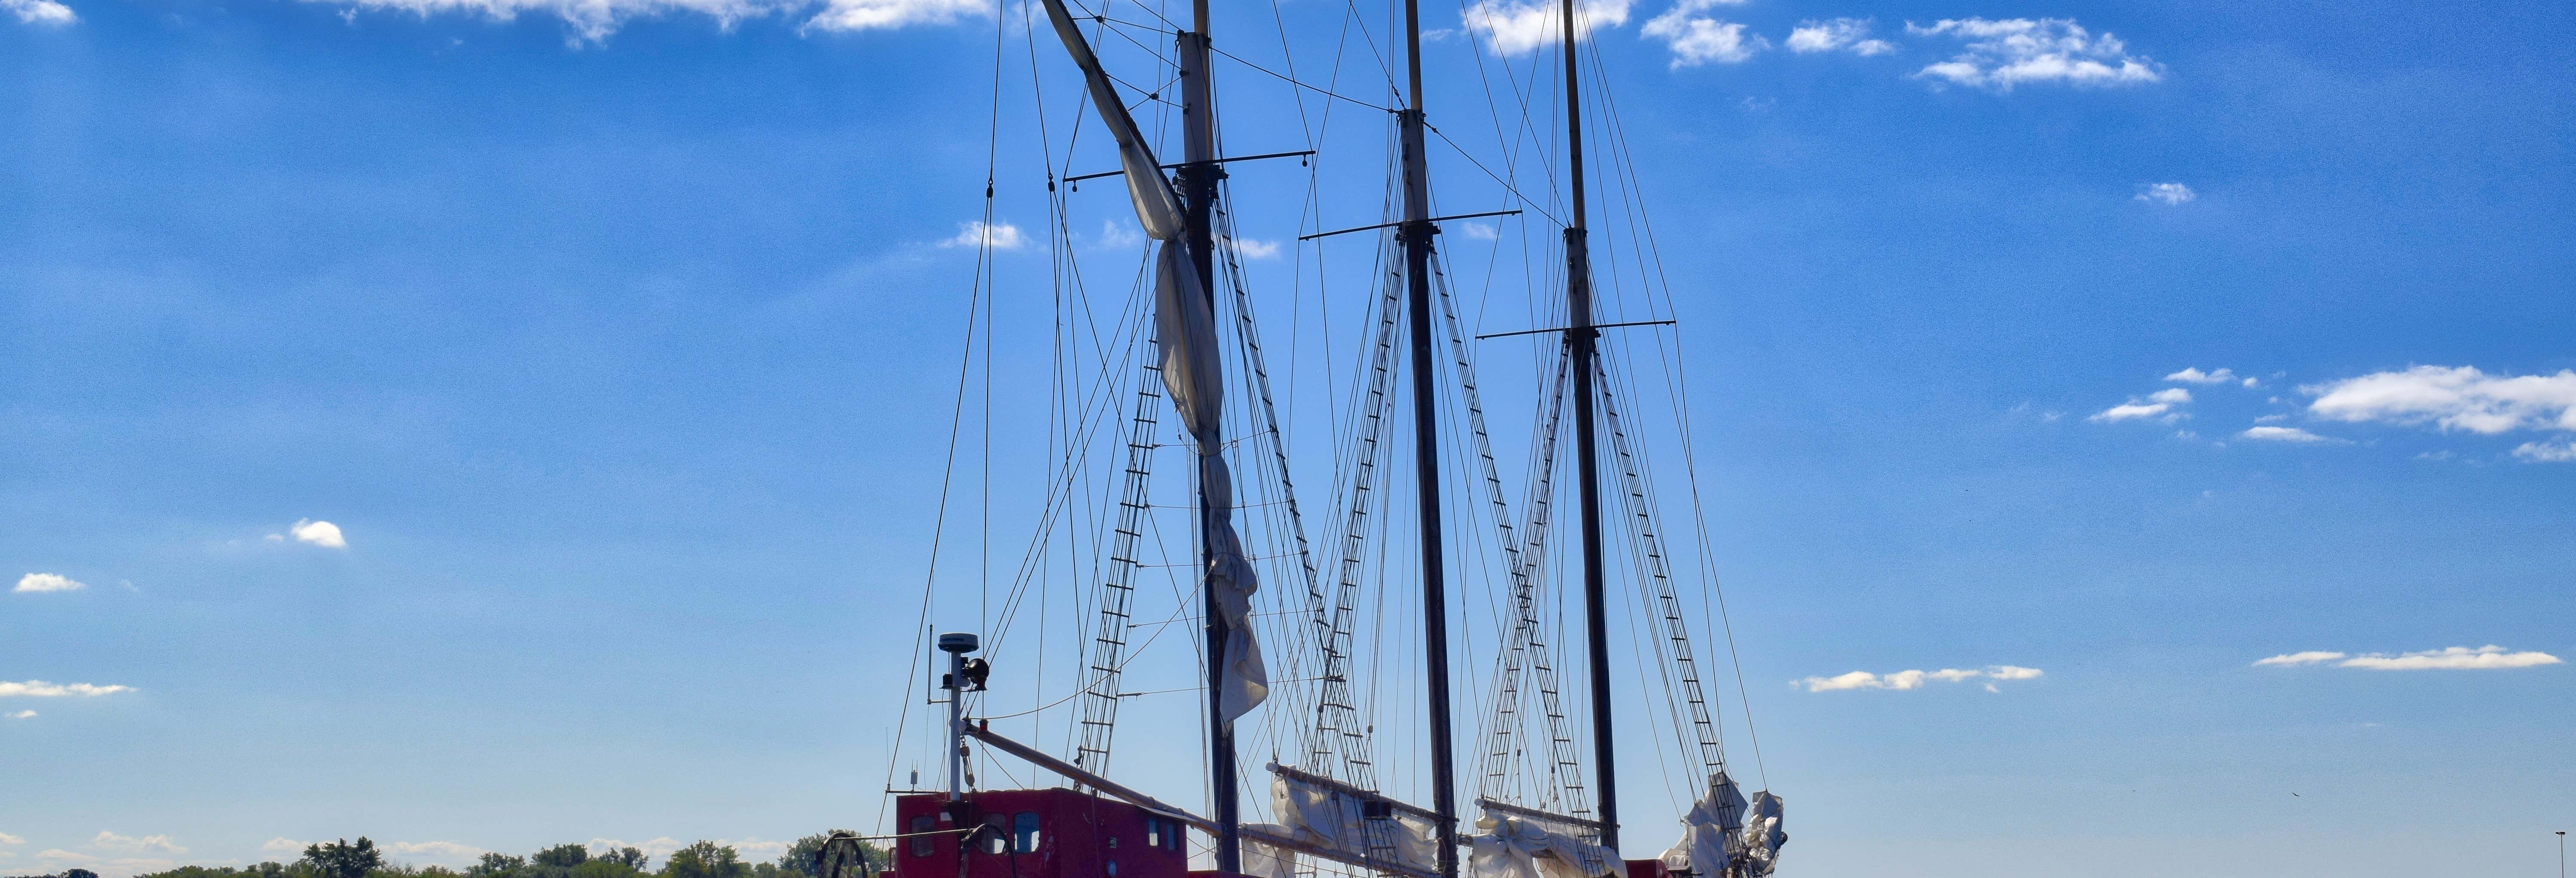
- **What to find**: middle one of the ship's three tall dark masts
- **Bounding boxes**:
[1401,0,1458,878]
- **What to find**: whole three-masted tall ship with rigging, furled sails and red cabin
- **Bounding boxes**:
[822,0,1788,878]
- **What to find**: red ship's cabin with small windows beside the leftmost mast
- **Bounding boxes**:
[894,788,1190,878]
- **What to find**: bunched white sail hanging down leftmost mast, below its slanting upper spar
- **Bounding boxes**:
[1154,238,1270,723]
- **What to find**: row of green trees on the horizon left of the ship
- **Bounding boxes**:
[5,829,886,878]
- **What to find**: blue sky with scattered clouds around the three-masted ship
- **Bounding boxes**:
[0,0,2576,875]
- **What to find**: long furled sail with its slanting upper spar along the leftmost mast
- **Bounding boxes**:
[1046,0,1270,723]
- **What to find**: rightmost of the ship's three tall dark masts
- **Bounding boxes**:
[1558,0,1618,852]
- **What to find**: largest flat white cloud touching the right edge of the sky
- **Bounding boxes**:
[2300,366,2576,435]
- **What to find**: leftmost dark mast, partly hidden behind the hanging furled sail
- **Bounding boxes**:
[1180,0,1244,873]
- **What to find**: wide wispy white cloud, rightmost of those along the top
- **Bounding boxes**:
[1906,18,2164,93]
